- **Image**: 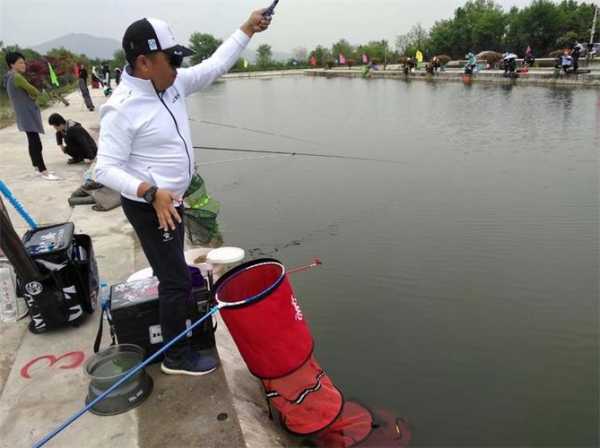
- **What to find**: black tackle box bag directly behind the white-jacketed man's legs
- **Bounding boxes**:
[94,277,216,362]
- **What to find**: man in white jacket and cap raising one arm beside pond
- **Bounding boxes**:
[96,10,271,375]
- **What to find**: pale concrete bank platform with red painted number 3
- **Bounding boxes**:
[0,90,294,448]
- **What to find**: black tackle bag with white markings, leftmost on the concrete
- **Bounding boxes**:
[22,223,98,334]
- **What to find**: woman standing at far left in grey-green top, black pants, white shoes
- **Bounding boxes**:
[4,52,60,180]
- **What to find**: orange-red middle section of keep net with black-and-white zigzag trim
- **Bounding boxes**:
[263,356,344,436]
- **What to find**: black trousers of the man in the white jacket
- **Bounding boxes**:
[121,198,192,358]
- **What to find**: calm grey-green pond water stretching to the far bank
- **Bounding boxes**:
[189,77,600,446]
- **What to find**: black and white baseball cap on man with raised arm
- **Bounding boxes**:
[123,18,194,63]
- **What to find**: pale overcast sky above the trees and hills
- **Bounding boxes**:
[0,0,530,52]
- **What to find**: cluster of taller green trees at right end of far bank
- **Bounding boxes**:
[396,0,597,59]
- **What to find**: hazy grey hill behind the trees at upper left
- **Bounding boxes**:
[33,33,121,59]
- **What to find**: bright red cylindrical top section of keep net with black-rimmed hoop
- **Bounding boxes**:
[215,259,313,379]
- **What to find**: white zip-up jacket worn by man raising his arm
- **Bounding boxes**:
[96,30,250,202]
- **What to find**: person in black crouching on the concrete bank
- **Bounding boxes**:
[48,113,98,165]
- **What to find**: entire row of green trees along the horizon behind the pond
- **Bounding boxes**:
[0,0,600,89]
